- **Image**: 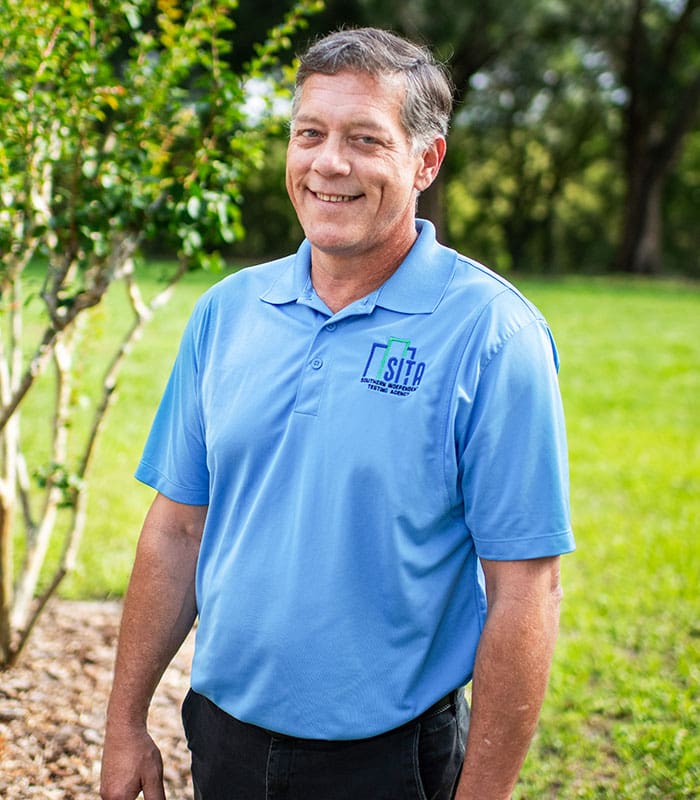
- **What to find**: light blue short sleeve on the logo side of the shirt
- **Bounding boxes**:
[459,319,574,561]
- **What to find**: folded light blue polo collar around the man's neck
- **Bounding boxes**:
[260,219,457,314]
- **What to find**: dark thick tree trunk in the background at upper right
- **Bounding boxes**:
[567,0,700,273]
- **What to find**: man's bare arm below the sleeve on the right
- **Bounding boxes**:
[456,557,561,800]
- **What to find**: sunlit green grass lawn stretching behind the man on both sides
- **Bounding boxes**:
[16,274,700,800]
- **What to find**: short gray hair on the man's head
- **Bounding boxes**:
[292,28,452,150]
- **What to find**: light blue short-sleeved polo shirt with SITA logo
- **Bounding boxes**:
[137,222,574,739]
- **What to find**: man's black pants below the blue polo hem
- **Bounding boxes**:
[182,690,469,800]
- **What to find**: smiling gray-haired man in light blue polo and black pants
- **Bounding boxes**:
[102,29,573,800]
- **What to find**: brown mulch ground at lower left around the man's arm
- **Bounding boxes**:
[0,600,193,800]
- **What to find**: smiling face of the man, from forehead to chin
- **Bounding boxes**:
[287,71,439,268]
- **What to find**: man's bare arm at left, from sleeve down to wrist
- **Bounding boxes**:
[107,496,205,728]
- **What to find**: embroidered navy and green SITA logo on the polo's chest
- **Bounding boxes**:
[362,336,425,397]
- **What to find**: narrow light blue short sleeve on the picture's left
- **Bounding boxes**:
[136,309,209,505]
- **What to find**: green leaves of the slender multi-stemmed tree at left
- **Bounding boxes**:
[0,0,319,282]
